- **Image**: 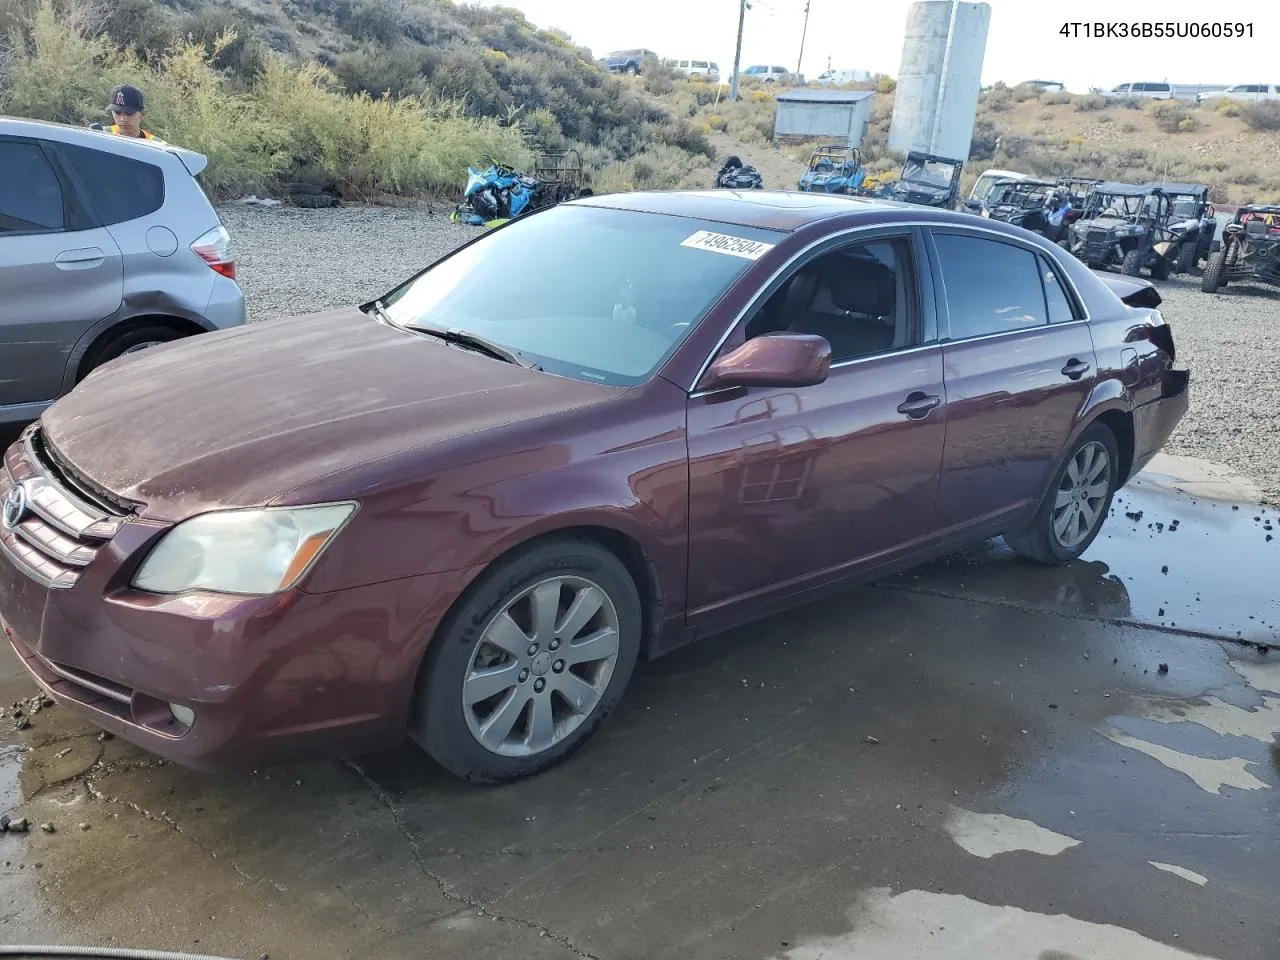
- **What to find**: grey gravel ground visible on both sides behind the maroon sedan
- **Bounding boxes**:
[220,206,1280,503]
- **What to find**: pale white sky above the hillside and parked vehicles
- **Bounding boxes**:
[481,0,1280,93]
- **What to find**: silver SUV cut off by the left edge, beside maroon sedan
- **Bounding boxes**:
[0,116,244,426]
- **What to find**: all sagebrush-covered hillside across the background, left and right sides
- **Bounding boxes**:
[0,0,1280,202]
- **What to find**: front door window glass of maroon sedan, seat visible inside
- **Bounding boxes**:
[745,237,920,364]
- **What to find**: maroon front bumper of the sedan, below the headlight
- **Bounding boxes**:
[0,431,472,769]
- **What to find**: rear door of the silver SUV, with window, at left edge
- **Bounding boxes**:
[0,137,124,407]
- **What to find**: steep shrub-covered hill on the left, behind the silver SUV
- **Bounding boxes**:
[0,0,714,197]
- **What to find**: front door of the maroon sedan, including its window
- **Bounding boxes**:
[689,233,946,622]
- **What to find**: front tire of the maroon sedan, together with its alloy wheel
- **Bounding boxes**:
[410,538,641,783]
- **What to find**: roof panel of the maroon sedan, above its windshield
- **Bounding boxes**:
[576,189,993,233]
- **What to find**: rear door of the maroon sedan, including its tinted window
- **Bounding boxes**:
[929,227,1097,536]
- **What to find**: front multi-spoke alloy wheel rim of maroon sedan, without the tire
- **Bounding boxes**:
[462,576,618,756]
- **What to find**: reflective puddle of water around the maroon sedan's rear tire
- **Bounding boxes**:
[884,476,1280,642]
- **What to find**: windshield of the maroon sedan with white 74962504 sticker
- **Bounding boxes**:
[384,206,783,387]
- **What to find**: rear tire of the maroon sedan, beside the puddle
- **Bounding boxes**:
[1005,424,1120,564]
